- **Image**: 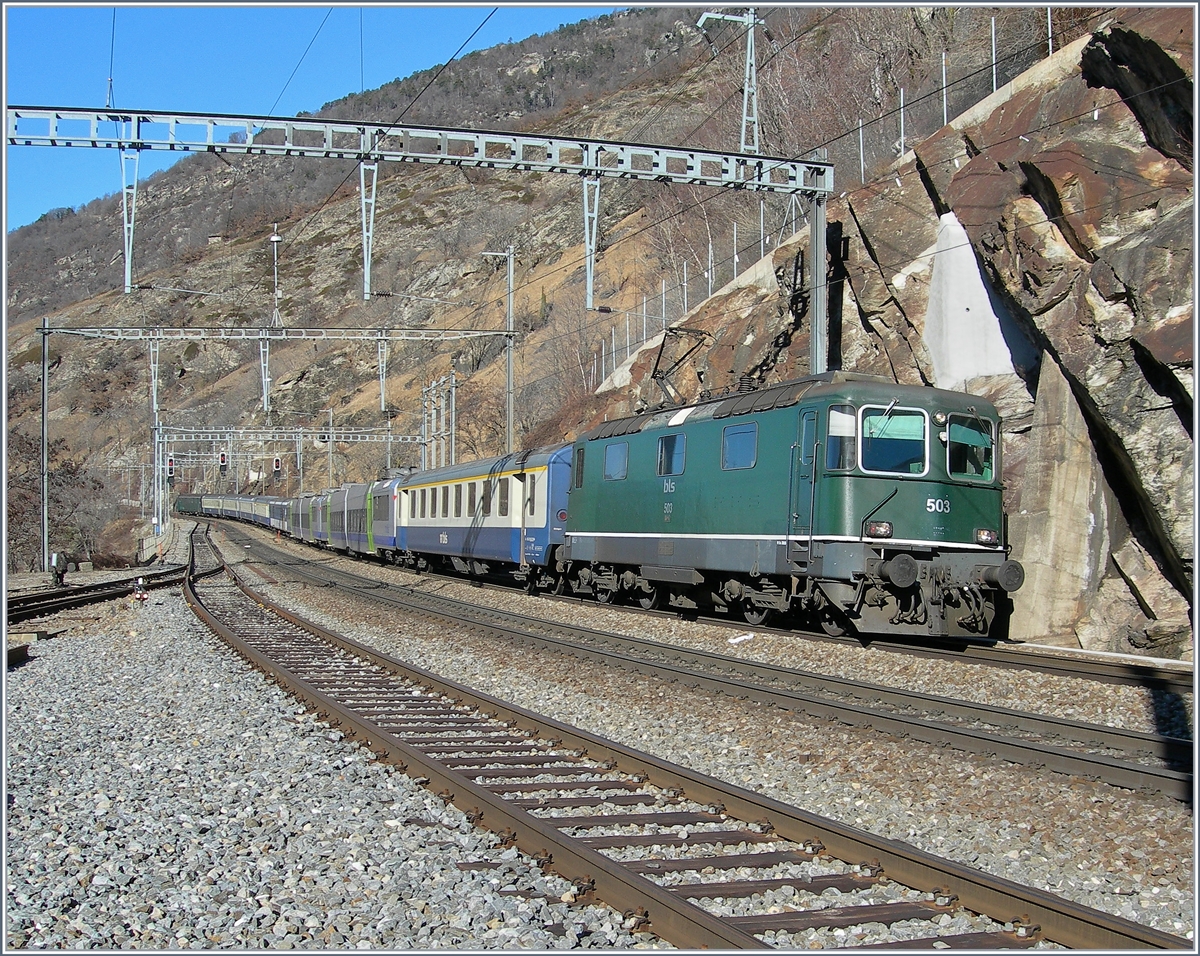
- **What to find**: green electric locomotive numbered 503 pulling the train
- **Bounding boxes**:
[556,372,1025,637]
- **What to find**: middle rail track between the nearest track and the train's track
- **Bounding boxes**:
[223,525,1193,800]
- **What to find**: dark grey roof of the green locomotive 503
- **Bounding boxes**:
[577,371,996,441]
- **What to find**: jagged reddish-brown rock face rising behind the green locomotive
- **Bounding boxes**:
[604,8,1194,657]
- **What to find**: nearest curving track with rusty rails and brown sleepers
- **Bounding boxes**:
[185,525,1190,949]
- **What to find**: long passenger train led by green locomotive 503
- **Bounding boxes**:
[176,371,1025,638]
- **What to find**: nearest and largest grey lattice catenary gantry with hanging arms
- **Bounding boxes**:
[6,106,833,372]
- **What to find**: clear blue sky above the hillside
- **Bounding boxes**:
[4,4,618,233]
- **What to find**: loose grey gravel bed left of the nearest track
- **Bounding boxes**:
[5,594,662,951]
